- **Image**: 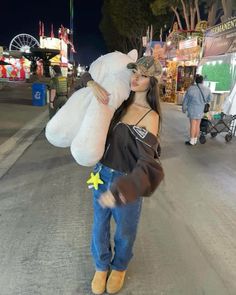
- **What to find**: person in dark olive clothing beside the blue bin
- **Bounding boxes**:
[49,65,68,119]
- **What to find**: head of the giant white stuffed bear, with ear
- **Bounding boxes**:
[89,50,137,82]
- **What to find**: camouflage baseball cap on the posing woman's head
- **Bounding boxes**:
[127,56,162,77]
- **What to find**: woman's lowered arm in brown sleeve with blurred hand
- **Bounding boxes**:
[99,133,164,208]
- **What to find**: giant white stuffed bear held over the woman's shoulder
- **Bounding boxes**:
[45,50,137,166]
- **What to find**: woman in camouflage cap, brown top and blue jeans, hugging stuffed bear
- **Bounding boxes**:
[78,57,164,294]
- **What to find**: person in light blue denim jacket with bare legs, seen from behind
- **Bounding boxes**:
[182,75,212,146]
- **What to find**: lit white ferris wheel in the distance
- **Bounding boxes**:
[9,34,39,52]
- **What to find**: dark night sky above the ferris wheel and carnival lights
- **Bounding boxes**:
[0,0,106,65]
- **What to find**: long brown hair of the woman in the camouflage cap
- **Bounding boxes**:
[108,77,162,136]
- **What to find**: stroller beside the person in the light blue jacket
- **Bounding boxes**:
[199,113,236,144]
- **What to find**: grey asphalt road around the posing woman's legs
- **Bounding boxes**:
[0,104,236,295]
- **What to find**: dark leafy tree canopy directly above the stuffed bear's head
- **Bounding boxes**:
[100,0,170,56]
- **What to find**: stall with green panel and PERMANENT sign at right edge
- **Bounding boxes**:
[197,18,236,112]
